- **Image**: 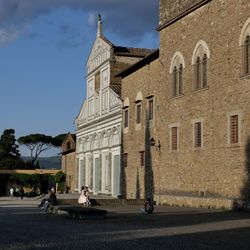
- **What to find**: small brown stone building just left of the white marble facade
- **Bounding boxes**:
[61,133,76,192]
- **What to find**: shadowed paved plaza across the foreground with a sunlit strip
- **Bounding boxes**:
[0,197,250,250]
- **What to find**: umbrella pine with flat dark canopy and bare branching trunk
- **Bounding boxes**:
[18,134,65,167]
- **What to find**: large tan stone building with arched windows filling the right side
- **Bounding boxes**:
[119,0,250,207]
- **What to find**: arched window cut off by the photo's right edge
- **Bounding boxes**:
[239,18,250,76]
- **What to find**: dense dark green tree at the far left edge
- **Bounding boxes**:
[0,129,24,169]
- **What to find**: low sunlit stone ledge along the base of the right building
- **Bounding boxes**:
[154,195,238,210]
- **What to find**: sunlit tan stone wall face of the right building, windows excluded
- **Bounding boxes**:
[122,0,250,206]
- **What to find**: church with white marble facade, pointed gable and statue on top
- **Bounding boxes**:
[75,16,151,197]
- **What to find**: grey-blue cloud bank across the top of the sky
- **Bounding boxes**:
[0,0,158,44]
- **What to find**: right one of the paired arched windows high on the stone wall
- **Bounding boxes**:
[192,40,210,91]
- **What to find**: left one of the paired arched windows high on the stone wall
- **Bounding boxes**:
[170,52,185,98]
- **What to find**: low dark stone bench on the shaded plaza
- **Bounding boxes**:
[57,206,107,219]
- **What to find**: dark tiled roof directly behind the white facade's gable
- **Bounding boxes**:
[114,46,154,57]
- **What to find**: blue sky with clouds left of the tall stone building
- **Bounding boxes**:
[0,0,159,156]
